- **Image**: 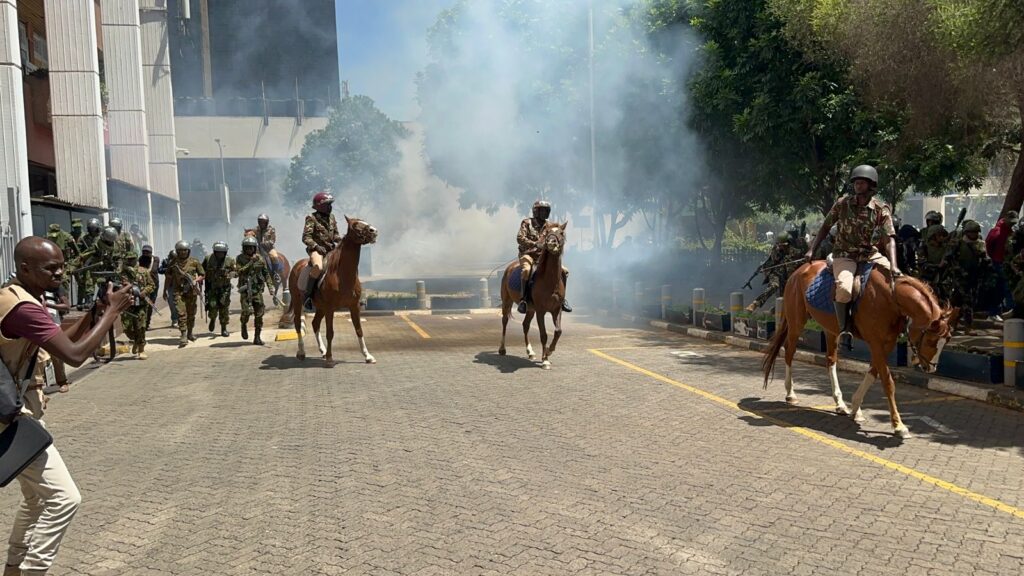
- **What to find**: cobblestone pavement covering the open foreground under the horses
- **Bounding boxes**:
[0,315,1024,575]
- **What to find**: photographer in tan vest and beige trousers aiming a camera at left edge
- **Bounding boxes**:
[0,237,132,576]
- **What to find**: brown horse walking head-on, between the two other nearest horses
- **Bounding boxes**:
[498,222,568,370]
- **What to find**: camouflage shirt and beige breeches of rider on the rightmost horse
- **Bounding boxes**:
[824,194,896,303]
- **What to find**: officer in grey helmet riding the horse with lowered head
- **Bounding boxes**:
[806,165,901,338]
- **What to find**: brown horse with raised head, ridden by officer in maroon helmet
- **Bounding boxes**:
[288,216,377,368]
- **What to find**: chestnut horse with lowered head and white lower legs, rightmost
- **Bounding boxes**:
[762,261,956,438]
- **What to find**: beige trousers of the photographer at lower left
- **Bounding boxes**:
[7,415,82,576]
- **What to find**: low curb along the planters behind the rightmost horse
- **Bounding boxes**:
[604,311,1024,412]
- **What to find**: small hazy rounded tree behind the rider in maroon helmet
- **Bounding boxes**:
[284,95,410,210]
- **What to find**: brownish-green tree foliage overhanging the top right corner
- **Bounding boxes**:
[771,0,1024,211]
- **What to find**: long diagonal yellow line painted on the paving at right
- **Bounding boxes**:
[588,348,1024,520]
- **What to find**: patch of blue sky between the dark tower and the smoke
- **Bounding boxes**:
[336,0,455,120]
